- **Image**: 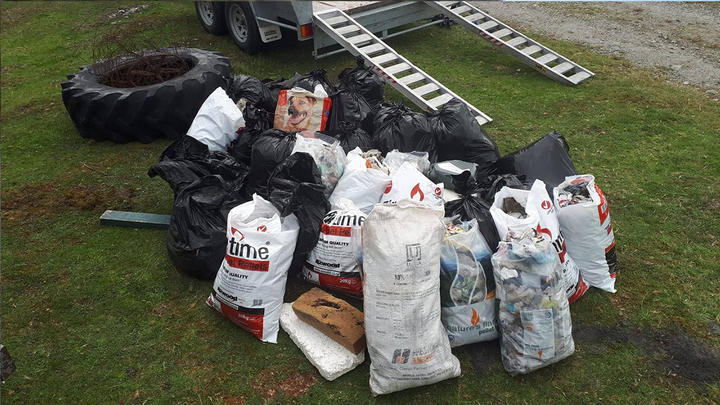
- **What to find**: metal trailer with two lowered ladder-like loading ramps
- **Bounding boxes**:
[195,1,594,125]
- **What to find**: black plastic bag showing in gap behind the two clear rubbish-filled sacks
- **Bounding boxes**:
[445,172,500,252]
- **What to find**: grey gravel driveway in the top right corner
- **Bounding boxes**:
[473,1,720,100]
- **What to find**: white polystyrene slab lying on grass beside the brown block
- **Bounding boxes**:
[280,303,365,381]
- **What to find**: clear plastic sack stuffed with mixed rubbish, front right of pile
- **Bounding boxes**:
[492,229,575,375]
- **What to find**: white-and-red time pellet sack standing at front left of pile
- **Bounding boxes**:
[207,194,300,343]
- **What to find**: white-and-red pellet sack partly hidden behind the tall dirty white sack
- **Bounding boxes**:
[303,198,365,297]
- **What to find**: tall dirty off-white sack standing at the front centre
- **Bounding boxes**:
[363,200,460,395]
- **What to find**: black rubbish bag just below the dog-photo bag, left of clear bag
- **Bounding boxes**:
[245,129,296,197]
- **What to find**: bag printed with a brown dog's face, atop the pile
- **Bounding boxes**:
[274,87,332,133]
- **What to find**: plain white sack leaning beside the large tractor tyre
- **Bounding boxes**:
[187,87,245,152]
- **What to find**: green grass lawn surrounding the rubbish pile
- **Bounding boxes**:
[0,2,720,403]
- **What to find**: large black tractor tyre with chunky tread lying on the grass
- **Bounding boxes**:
[61,48,233,143]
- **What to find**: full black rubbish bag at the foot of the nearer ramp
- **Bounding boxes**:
[429,98,500,172]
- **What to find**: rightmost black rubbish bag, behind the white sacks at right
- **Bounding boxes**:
[493,131,577,191]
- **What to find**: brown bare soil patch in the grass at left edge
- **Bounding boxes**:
[2,183,137,222]
